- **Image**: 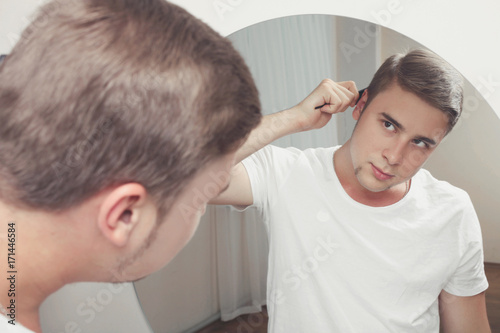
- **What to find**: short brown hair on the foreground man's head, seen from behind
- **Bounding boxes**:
[0,0,262,215]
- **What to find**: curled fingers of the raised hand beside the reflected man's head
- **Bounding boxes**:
[316,79,359,114]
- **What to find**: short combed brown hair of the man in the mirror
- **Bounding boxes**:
[365,49,463,132]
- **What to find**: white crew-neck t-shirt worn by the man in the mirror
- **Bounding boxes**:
[243,146,488,333]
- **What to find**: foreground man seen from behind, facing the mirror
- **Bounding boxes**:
[0,0,261,332]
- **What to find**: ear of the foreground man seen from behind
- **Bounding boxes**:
[97,183,147,247]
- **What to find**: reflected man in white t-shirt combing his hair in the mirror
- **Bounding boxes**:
[211,50,490,333]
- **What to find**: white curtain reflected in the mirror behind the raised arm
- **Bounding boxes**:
[210,15,338,320]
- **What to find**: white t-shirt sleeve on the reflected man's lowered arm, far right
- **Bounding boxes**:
[444,196,488,296]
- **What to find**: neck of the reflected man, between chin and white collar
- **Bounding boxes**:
[333,140,409,207]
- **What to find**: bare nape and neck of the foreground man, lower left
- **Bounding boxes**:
[0,202,101,332]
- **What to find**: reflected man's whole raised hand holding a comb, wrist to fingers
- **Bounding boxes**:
[295,79,359,131]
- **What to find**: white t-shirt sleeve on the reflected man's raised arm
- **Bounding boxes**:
[242,145,301,212]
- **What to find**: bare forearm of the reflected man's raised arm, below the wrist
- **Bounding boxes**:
[235,108,302,163]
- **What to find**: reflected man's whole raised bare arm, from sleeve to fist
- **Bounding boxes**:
[210,79,358,206]
